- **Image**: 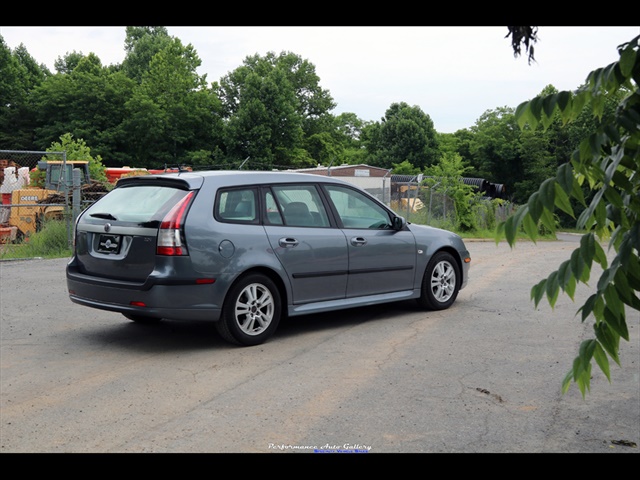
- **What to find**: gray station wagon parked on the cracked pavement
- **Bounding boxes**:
[66,171,471,345]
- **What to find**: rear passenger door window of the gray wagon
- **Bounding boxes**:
[272,185,329,227]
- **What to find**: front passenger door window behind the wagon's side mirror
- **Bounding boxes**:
[325,185,391,229]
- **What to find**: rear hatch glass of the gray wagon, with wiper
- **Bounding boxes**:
[84,185,189,224]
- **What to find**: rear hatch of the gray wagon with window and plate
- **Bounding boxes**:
[75,176,200,283]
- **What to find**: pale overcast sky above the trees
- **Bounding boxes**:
[0,26,640,133]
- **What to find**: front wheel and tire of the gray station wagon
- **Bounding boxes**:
[417,252,461,310]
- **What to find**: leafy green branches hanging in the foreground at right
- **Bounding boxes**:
[497,31,640,397]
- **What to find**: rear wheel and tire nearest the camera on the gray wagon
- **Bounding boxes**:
[216,274,282,346]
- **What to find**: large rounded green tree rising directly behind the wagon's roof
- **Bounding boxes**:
[214,52,340,168]
